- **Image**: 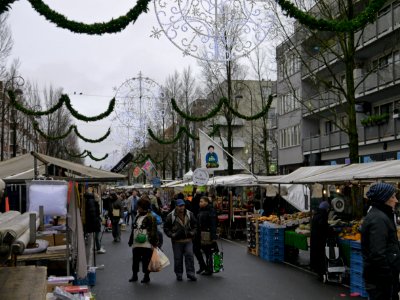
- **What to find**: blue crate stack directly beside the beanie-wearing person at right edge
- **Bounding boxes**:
[350,241,368,298]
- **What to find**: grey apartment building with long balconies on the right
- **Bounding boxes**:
[276,0,400,173]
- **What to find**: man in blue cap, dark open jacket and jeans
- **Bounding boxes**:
[164,199,197,281]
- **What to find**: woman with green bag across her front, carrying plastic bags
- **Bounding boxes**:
[128,196,158,283]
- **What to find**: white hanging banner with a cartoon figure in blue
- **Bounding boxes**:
[199,130,228,171]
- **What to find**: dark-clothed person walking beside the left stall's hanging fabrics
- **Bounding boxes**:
[84,193,106,254]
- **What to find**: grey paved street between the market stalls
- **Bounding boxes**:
[92,231,362,300]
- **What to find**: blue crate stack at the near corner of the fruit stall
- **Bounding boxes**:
[259,222,285,262]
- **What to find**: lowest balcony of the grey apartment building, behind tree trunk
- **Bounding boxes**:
[303,118,400,154]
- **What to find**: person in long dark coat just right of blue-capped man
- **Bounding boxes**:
[195,196,218,275]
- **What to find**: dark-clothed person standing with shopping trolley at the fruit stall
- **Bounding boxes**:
[310,201,332,281]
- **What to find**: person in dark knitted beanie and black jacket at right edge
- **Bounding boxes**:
[361,183,400,300]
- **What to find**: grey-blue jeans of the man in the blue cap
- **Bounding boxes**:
[172,241,195,276]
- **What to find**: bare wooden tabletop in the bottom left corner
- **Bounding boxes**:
[0,266,47,300]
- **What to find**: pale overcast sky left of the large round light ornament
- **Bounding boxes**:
[9,0,197,166]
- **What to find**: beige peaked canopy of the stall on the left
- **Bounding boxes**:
[0,152,126,183]
